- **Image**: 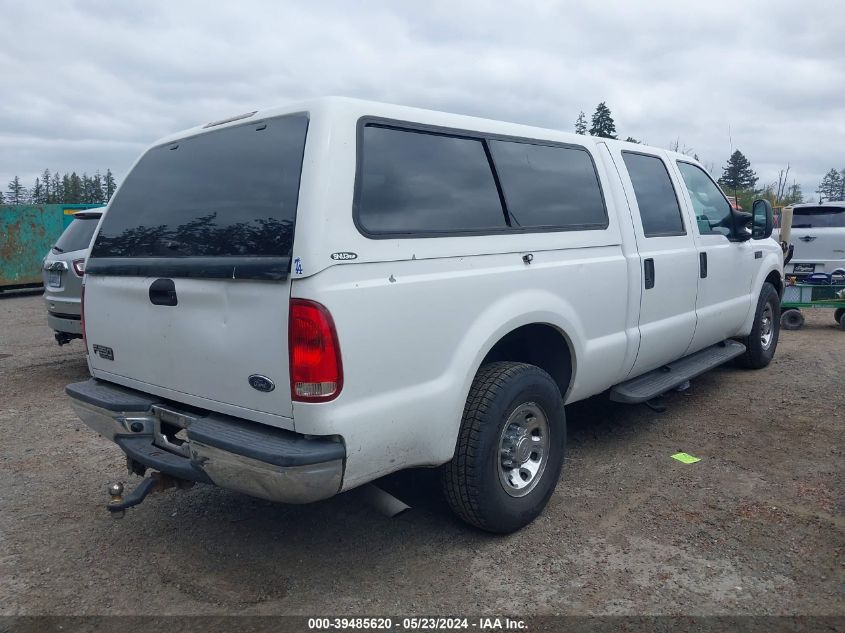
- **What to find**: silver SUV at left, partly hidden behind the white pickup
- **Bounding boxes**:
[42,210,103,345]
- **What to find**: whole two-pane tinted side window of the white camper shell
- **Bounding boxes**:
[353,118,608,238]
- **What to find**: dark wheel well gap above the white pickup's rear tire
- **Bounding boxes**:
[481,323,572,398]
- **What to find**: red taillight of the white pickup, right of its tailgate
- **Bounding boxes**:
[288,299,343,402]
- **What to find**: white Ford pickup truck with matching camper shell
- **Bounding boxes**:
[67,98,783,532]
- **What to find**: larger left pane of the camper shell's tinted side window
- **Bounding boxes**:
[356,125,507,234]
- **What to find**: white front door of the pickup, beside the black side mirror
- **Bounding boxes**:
[676,160,752,354]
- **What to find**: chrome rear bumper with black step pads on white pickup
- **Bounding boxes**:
[66,378,346,503]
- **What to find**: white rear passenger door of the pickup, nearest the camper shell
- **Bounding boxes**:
[611,149,698,376]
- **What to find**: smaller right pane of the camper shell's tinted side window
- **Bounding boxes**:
[490,140,607,229]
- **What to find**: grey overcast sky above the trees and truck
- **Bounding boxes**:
[0,0,845,197]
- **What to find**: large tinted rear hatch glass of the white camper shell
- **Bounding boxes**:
[91,114,308,258]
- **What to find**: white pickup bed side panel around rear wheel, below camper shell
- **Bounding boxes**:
[292,247,627,488]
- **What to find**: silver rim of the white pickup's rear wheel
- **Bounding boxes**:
[496,402,550,497]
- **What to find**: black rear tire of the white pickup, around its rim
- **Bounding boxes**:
[442,362,566,534]
